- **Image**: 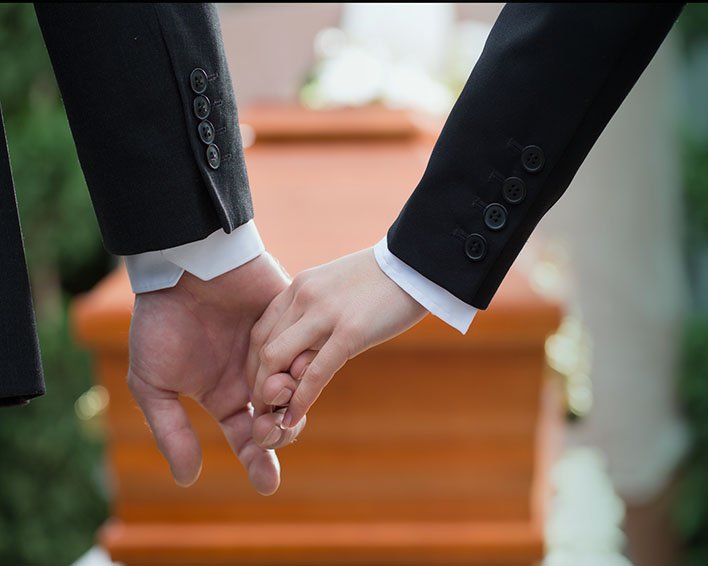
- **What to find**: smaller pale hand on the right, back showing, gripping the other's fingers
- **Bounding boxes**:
[248,248,427,448]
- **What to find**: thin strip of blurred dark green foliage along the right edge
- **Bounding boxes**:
[674,4,708,566]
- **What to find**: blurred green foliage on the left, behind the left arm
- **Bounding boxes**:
[0,4,111,566]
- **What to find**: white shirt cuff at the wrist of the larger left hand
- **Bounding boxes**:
[125,220,265,294]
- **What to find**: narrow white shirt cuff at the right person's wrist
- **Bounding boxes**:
[374,237,477,334]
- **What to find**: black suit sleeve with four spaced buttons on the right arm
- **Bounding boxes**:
[388,3,682,309]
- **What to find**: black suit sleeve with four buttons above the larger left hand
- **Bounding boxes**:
[35,3,253,255]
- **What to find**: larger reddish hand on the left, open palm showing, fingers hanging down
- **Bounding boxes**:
[128,254,301,495]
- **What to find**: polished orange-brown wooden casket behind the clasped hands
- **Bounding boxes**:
[73,107,561,566]
